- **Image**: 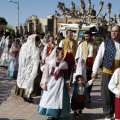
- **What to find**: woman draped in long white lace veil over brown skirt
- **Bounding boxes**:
[15,34,40,102]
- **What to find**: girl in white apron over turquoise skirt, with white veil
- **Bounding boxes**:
[38,47,70,120]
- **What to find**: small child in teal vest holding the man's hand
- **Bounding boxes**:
[71,75,93,118]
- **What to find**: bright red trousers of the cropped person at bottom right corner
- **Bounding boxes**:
[115,97,120,119]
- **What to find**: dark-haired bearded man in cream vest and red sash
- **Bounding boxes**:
[75,31,98,102]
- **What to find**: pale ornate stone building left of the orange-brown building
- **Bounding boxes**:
[15,15,53,36]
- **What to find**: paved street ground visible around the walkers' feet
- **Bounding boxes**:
[0,68,112,120]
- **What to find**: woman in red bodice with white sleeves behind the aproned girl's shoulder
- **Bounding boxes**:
[42,35,55,64]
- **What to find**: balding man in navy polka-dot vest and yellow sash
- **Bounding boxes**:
[92,25,120,120]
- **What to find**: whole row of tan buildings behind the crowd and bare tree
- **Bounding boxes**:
[16,13,107,36]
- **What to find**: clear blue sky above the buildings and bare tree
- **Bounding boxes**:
[0,0,120,26]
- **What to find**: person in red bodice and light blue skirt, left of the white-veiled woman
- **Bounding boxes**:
[7,39,20,78]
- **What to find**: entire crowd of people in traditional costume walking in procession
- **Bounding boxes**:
[0,25,120,120]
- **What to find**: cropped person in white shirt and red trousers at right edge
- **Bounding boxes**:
[108,68,120,120]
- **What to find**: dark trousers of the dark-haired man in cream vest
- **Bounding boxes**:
[86,66,92,100]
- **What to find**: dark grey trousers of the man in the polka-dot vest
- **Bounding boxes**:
[101,73,115,118]
